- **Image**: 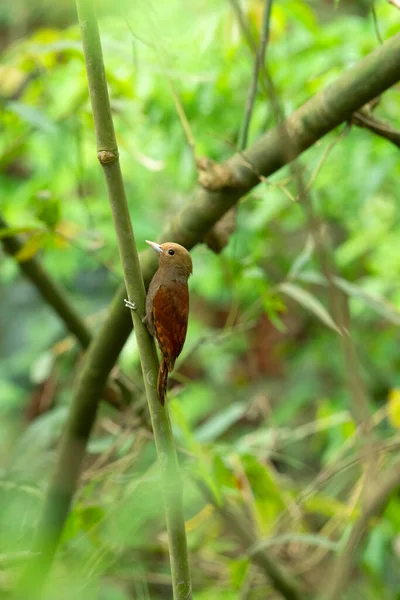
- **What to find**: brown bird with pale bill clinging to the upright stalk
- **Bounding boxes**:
[125,240,193,404]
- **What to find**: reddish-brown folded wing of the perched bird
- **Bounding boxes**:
[152,283,189,371]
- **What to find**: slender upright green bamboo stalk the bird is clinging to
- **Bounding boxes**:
[76,0,192,600]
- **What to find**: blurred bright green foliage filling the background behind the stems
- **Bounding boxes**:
[0,0,400,600]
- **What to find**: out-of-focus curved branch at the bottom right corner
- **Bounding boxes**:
[322,461,400,600]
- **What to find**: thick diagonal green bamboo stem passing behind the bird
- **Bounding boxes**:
[26,34,400,596]
